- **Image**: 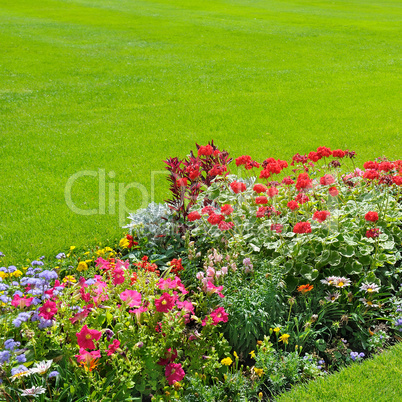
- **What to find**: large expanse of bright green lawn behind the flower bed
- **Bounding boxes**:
[0,0,402,263]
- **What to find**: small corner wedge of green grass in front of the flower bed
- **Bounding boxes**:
[276,343,402,402]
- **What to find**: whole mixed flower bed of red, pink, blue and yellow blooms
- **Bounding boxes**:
[0,143,402,401]
